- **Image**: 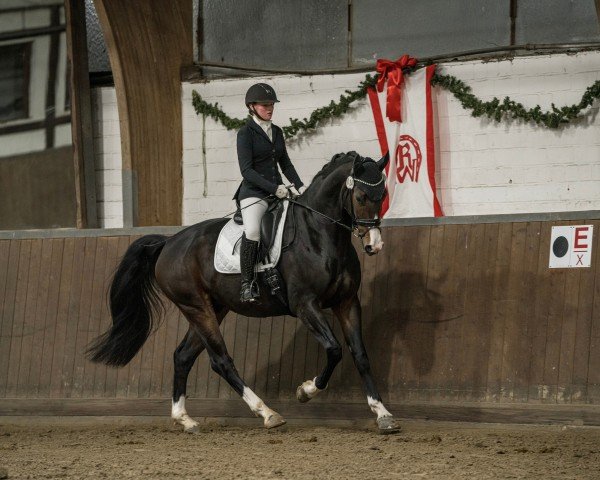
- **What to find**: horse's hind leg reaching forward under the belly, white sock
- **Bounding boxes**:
[179,293,285,428]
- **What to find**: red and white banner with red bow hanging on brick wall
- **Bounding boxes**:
[368,61,443,218]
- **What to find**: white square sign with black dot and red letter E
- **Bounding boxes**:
[549,225,594,268]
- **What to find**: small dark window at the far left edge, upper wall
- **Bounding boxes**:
[0,42,31,122]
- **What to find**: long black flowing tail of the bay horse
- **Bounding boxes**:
[87,235,167,367]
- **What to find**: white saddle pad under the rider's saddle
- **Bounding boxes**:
[215,200,289,273]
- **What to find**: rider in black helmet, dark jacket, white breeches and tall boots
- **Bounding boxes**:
[236,83,306,302]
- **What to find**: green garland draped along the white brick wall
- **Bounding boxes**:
[192,74,600,139]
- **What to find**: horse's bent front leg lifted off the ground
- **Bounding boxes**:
[296,299,342,403]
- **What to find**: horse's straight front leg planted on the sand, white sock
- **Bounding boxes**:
[333,295,400,433]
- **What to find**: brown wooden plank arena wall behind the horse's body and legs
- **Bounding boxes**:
[0,212,600,424]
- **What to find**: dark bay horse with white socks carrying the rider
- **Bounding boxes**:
[88,152,399,433]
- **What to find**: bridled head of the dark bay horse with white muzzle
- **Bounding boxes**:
[346,153,390,255]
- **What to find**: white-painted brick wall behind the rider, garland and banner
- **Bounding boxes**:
[90,52,600,226]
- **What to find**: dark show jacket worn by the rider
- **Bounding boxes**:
[236,117,303,201]
